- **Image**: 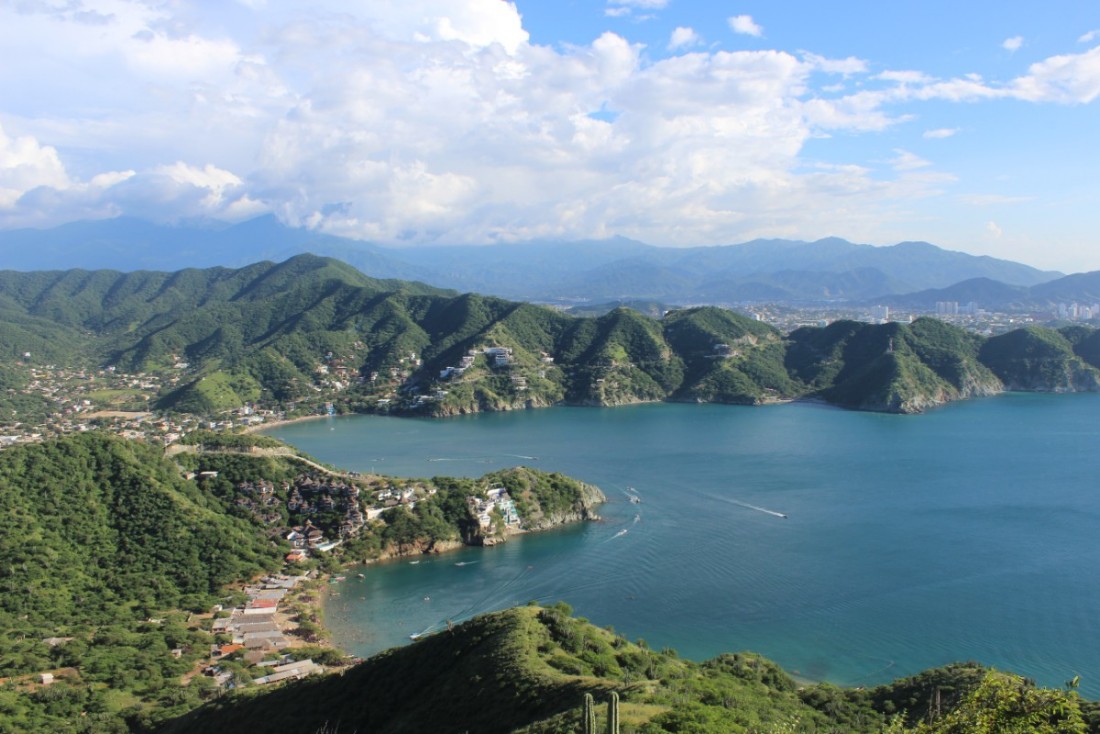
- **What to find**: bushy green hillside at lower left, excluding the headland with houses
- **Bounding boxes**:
[0,432,278,732]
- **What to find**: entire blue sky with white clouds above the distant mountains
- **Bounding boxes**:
[0,0,1100,272]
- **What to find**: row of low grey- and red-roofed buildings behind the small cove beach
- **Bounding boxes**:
[204,574,325,688]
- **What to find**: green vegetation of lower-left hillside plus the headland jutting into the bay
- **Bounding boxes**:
[0,431,603,732]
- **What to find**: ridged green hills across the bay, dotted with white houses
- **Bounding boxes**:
[0,255,1100,415]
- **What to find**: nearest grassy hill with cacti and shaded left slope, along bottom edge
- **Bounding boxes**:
[163,604,1096,734]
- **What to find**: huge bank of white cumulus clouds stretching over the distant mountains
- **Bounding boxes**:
[0,0,1100,244]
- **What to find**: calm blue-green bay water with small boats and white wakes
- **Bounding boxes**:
[264,395,1100,698]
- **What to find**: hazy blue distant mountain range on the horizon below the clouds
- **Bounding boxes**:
[0,216,1082,308]
